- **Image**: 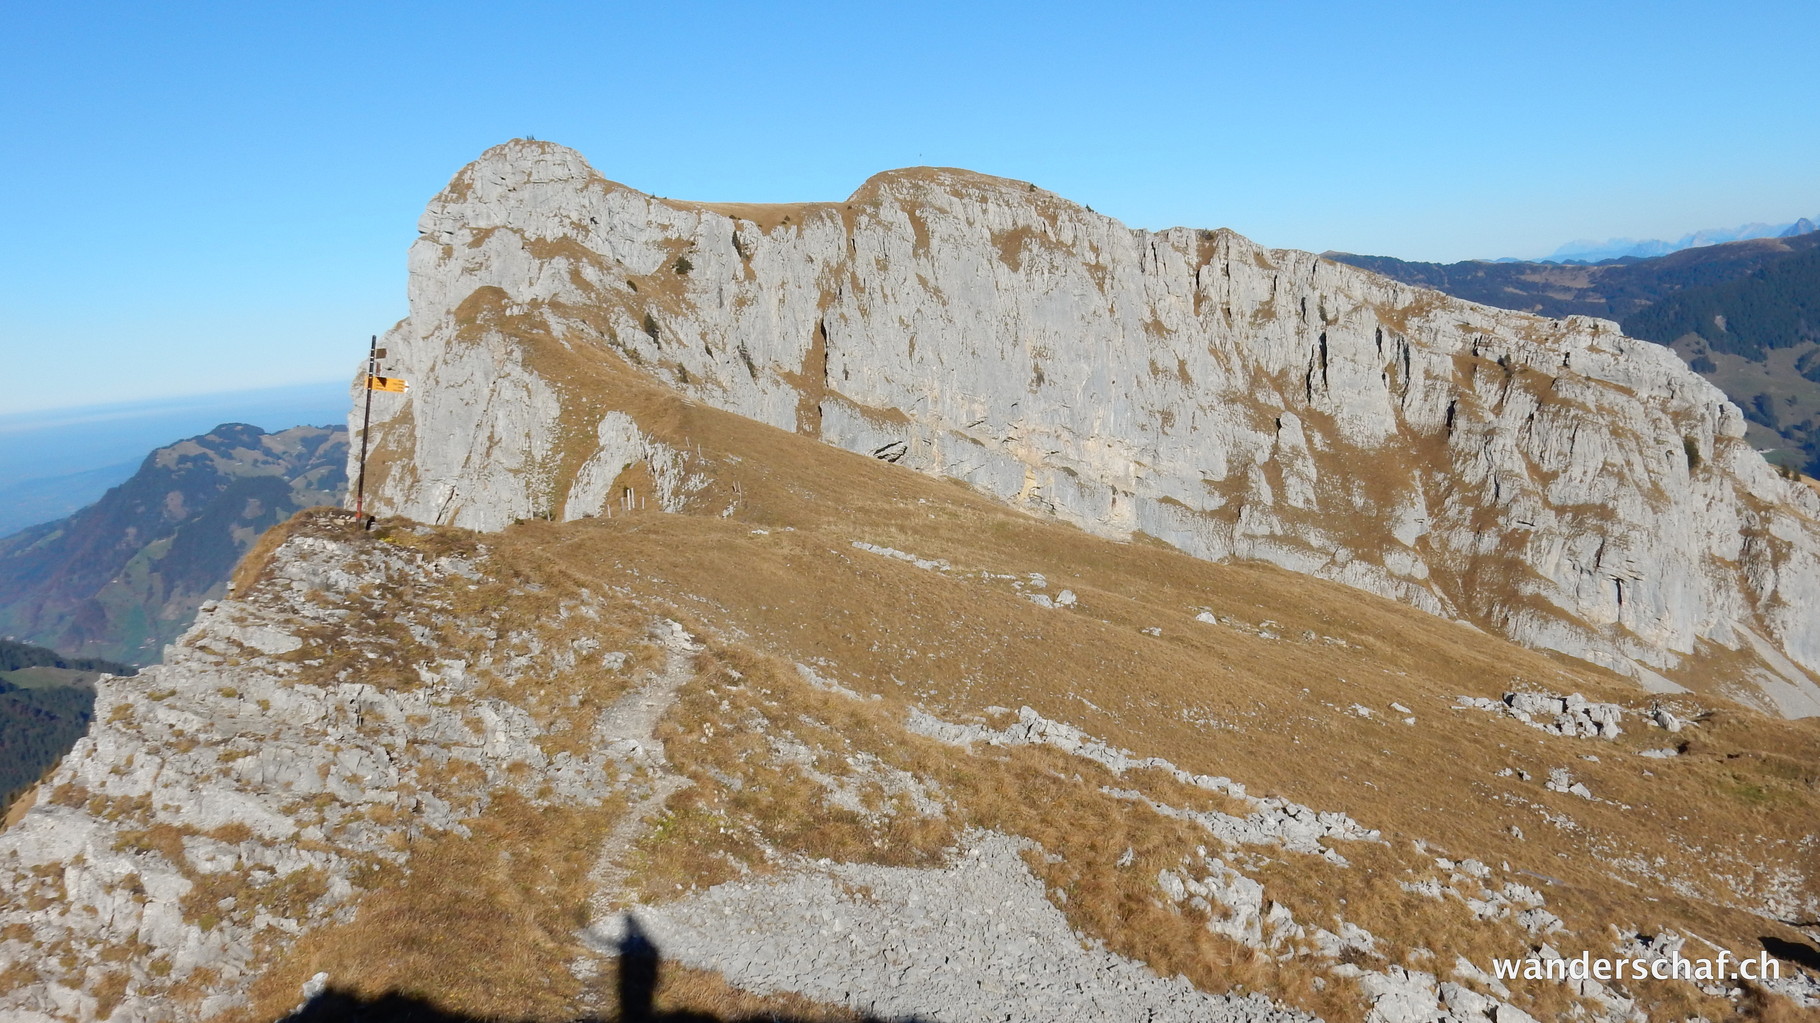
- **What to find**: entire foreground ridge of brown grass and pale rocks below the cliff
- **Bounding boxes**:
[0,433,1820,1023]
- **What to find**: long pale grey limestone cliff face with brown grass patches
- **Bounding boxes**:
[357,140,1820,714]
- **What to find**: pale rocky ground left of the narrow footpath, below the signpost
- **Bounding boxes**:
[0,516,633,1023]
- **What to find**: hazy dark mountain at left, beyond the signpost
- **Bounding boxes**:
[0,424,348,664]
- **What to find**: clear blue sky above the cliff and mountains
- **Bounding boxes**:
[0,0,1820,413]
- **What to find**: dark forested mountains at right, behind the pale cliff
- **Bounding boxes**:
[1323,229,1820,475]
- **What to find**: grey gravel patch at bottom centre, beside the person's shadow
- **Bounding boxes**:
[592,832,1312,1023]
